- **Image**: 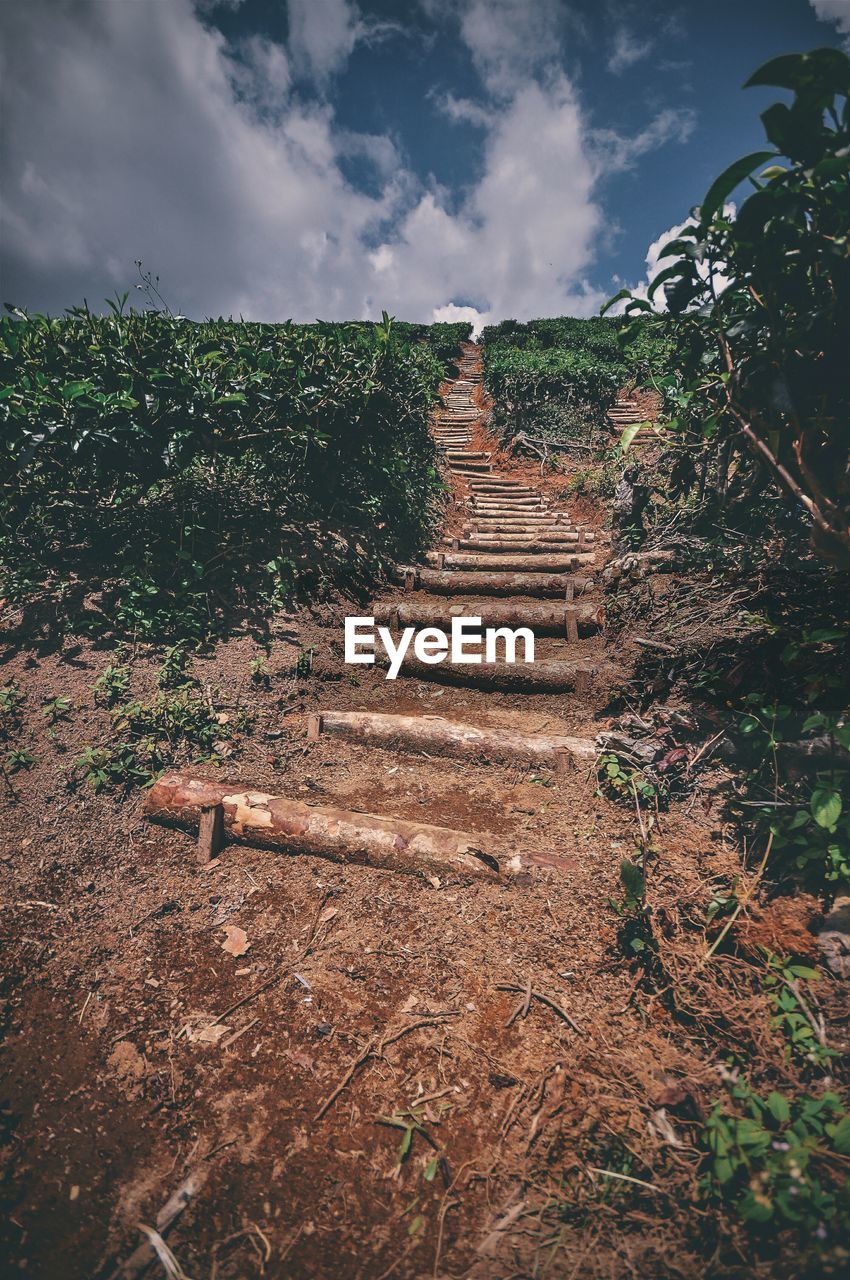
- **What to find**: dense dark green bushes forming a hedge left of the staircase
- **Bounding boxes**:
[0,301,469,636]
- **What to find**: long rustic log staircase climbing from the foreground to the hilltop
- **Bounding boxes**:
[147,343,604,878]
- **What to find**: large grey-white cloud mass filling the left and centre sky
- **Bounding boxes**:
[0,0,701,324]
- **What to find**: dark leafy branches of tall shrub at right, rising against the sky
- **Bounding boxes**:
[606,49,850,567]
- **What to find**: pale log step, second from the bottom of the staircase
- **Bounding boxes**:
[307,712,599,773]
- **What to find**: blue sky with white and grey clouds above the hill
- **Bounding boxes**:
[0,0,850,328]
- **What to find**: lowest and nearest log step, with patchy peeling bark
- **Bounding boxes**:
[143,773,511,879]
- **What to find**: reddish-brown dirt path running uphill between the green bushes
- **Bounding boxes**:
[3,346,734,1280]
